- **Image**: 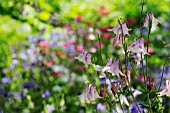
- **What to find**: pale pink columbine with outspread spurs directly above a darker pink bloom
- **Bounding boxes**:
[109,22,131,36]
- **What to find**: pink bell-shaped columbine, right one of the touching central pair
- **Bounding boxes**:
[108,59,125,76]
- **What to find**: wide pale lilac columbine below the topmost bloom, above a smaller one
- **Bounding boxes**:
[128,38,147,54]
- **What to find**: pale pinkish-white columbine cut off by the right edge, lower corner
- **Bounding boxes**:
[158,80,170,96]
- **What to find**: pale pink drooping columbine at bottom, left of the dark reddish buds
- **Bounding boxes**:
[79,84,102,101]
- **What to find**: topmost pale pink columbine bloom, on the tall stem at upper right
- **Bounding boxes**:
[144,13,162,27]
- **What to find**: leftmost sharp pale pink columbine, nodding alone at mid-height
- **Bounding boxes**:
[75,51,92,67]
